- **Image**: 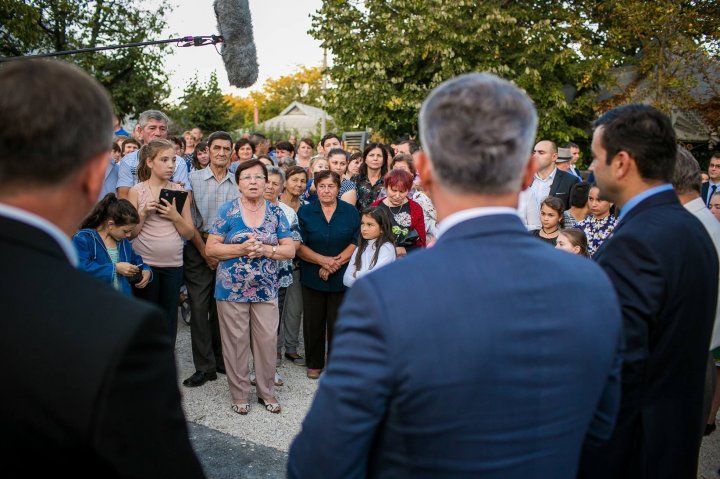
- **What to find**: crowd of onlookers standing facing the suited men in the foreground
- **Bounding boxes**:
[83,102,720,424]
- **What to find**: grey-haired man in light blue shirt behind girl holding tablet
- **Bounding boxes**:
[117,110,192,199]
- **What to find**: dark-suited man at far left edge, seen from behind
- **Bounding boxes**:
[0,60,204,478]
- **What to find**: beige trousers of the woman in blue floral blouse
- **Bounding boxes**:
[217,299,279,404]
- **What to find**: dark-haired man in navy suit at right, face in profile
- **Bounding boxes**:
[580,105,718,479]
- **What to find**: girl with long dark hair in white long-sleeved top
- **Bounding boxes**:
[343,206,396,287]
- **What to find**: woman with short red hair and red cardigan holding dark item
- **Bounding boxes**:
[372,170,426,257]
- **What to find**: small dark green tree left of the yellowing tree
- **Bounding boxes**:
[168,72,232,132]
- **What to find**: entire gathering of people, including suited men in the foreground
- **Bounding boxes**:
[0,61,720,478]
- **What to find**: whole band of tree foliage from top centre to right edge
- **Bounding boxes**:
[310,0,720,143]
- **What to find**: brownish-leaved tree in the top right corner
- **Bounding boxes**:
[589,0,720,139]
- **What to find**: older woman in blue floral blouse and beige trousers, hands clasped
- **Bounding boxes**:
[205,160,295,414]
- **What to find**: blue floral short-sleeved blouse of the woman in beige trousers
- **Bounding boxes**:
[210,198,292,303]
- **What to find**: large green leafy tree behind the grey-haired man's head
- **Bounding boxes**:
[310,0,603,141]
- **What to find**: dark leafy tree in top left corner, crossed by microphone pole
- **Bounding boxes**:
[0,0,169,115]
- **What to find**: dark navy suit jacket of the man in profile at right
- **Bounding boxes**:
[580,191,718,479]
